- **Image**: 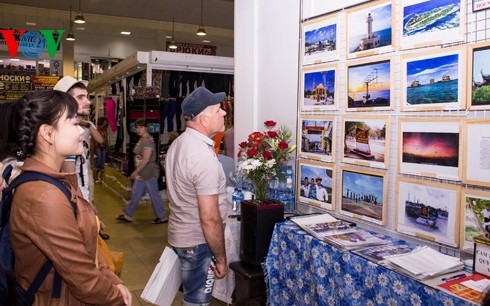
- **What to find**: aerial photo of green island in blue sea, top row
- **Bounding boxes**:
[403,0,461,37]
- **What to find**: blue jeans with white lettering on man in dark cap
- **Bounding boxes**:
[174,244,214,306]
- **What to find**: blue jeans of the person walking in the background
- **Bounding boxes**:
[123,177,167,219]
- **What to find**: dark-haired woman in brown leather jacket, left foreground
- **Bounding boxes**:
[0,90,132,305]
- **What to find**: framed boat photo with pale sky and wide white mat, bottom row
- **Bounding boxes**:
[396,176,461,247]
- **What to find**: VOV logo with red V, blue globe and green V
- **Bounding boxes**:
[0,29,65,58]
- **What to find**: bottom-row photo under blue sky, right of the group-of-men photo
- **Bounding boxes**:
[341,170,384,221]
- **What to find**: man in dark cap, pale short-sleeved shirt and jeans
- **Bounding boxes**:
[165,87,228,305]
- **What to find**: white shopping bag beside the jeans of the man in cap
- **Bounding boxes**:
[141,247,182,306]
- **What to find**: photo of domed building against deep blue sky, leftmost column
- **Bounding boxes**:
[303,69,335,106]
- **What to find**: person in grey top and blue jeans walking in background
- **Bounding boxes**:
[117,119,168,224]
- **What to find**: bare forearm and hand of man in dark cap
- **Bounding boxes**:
[197,194,228,278]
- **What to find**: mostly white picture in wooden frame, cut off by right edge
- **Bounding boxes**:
[462,119,490,187]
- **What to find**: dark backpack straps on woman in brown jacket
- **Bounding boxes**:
[2,171,77,298]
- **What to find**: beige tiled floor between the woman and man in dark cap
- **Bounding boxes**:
[95,184,226,306]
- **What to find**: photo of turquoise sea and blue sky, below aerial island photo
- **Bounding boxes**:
[406,54,459,105]
